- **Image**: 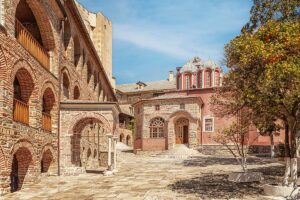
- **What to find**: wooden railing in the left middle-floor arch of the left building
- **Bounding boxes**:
[13,99,29,125]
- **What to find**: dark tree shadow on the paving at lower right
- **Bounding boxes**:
[168,166,284,199]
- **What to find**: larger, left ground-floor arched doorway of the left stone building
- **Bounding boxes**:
[10,147,33,192]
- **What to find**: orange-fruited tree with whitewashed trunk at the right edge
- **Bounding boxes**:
[213,20,300,187]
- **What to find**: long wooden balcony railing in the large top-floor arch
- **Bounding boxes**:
[16,19,50,70]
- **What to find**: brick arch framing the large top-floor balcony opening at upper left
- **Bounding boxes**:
[12,0,55,50]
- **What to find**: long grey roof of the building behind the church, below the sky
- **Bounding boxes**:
[117,79,176,93]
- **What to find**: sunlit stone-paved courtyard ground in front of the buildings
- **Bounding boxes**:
[4,149,283,200]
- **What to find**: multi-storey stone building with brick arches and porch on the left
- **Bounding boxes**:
[0,0,120,195]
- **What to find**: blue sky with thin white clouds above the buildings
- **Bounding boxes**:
[78,0,252,84]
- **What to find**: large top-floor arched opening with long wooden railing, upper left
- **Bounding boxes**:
[15,0,55,70]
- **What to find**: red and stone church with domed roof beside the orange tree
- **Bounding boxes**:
[132,57,284,150]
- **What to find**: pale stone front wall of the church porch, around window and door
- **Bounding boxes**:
[134,98,201,150]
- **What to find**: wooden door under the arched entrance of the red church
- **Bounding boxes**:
[175,118,189,144]
